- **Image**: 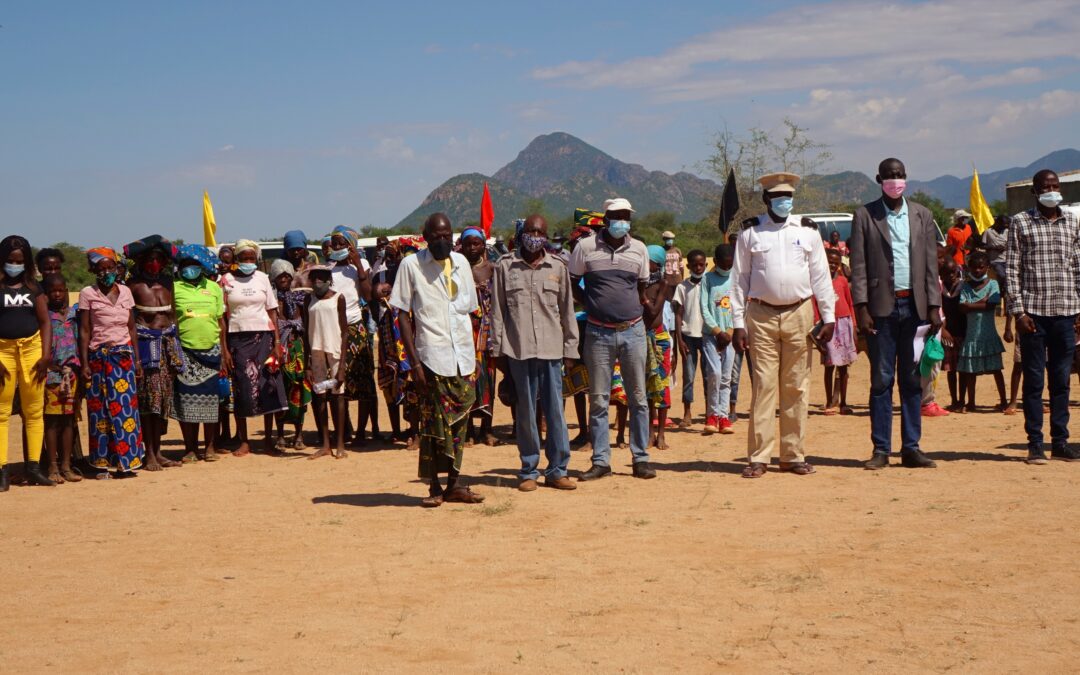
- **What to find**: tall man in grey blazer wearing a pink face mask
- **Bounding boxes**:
[851,158,942,470]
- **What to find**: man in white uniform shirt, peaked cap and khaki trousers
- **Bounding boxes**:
[731,173,836,478]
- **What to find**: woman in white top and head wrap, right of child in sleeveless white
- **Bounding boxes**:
[321,225,378,443]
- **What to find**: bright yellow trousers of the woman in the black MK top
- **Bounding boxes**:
[0,333,45,467]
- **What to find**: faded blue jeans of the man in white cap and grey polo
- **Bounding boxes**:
[583,321,649,467]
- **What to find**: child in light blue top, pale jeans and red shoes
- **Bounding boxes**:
[698,244,735,435]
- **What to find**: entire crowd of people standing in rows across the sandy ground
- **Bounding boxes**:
[0,159,1080,507]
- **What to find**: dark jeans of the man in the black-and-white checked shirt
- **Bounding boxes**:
[1020,314,1076,450]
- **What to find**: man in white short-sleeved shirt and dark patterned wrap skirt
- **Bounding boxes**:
[390,213,484,508]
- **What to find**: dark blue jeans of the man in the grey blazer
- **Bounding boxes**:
[866,298,922,455]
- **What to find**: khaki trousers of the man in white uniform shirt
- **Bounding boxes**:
[745,300,813,464]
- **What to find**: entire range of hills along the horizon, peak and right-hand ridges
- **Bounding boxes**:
[397,132,1080,226]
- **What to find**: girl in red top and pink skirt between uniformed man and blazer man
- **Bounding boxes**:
[814,248,859,415]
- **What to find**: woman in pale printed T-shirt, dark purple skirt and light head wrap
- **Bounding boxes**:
[221,239,287,457]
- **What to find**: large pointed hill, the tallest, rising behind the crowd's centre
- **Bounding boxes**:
[399,132,720,227]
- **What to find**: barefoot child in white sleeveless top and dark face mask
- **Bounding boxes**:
[303,265,349,459]
